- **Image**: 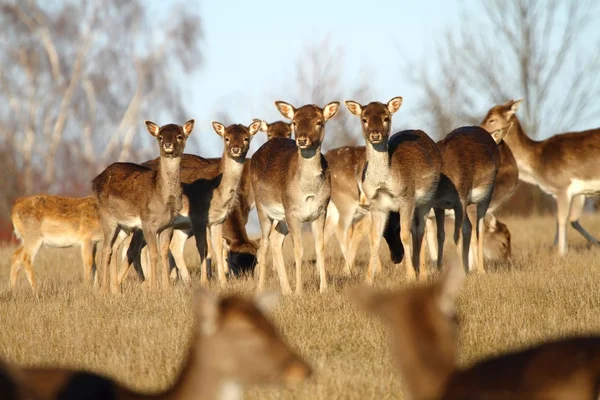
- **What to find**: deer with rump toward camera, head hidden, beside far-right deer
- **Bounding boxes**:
[433,126,503,273]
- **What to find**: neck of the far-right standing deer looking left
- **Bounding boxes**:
[503,116,541,184]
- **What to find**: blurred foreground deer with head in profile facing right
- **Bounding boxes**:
[11,289,312,400]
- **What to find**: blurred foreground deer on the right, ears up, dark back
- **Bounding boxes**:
[352,263,600,400]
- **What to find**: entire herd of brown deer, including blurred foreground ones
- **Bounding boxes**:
[0,97,600,400]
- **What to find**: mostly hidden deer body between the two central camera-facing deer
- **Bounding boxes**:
[325,146,404,275]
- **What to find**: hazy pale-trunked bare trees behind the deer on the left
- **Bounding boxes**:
[0,0,202,198]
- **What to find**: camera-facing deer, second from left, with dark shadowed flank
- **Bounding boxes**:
[119,121,260,285]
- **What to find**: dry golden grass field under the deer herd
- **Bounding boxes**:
[0,216,600,399]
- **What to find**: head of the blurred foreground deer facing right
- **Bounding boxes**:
[194,289,312,386]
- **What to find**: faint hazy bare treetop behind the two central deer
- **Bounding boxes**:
[282,37,372,150]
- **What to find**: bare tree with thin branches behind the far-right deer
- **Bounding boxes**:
[405,0,600,137]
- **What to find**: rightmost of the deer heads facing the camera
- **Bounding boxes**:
[344,97,402,144]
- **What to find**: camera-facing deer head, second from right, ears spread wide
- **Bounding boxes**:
[275,101,340,149]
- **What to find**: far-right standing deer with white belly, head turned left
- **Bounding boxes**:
[481,100,600,255]
